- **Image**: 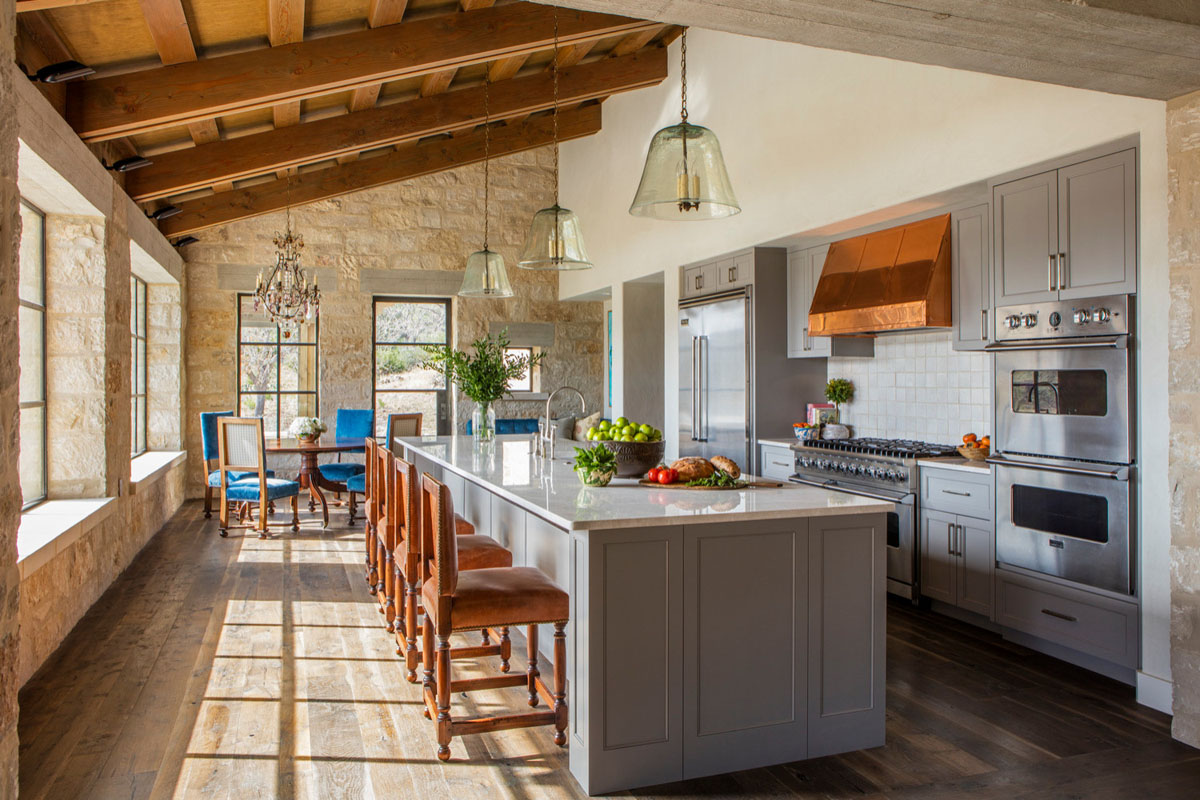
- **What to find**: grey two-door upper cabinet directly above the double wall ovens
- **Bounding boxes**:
[992,149,1138,306]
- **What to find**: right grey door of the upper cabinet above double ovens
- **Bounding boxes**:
[1058,150,1138,299]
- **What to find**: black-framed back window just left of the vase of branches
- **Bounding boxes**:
[373,297,450,435]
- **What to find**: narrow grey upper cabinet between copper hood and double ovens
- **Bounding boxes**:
[950,203,995,350]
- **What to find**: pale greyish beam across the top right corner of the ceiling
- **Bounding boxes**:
[536,0,1200,100]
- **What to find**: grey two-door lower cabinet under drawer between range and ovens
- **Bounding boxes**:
[920,509,996,619]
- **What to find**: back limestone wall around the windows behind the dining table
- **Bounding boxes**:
[185,143,604,497]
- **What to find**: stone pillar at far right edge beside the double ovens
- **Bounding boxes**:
[1166,92,1200,747]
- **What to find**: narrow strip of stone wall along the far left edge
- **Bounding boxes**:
[0,2,20,798]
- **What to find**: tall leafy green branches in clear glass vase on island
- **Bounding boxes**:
[420,329,545,441]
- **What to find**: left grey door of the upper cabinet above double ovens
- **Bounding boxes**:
[992,170,1058,306]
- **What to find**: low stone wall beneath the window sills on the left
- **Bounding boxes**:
[15,460,185,686]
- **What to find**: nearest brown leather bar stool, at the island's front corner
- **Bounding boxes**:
[421,475,570,760]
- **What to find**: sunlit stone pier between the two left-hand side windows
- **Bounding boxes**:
[46,215,108,499]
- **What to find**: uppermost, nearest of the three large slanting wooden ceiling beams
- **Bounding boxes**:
[67,2,661,142]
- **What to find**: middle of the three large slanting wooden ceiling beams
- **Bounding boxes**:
[125,47,667,201]
